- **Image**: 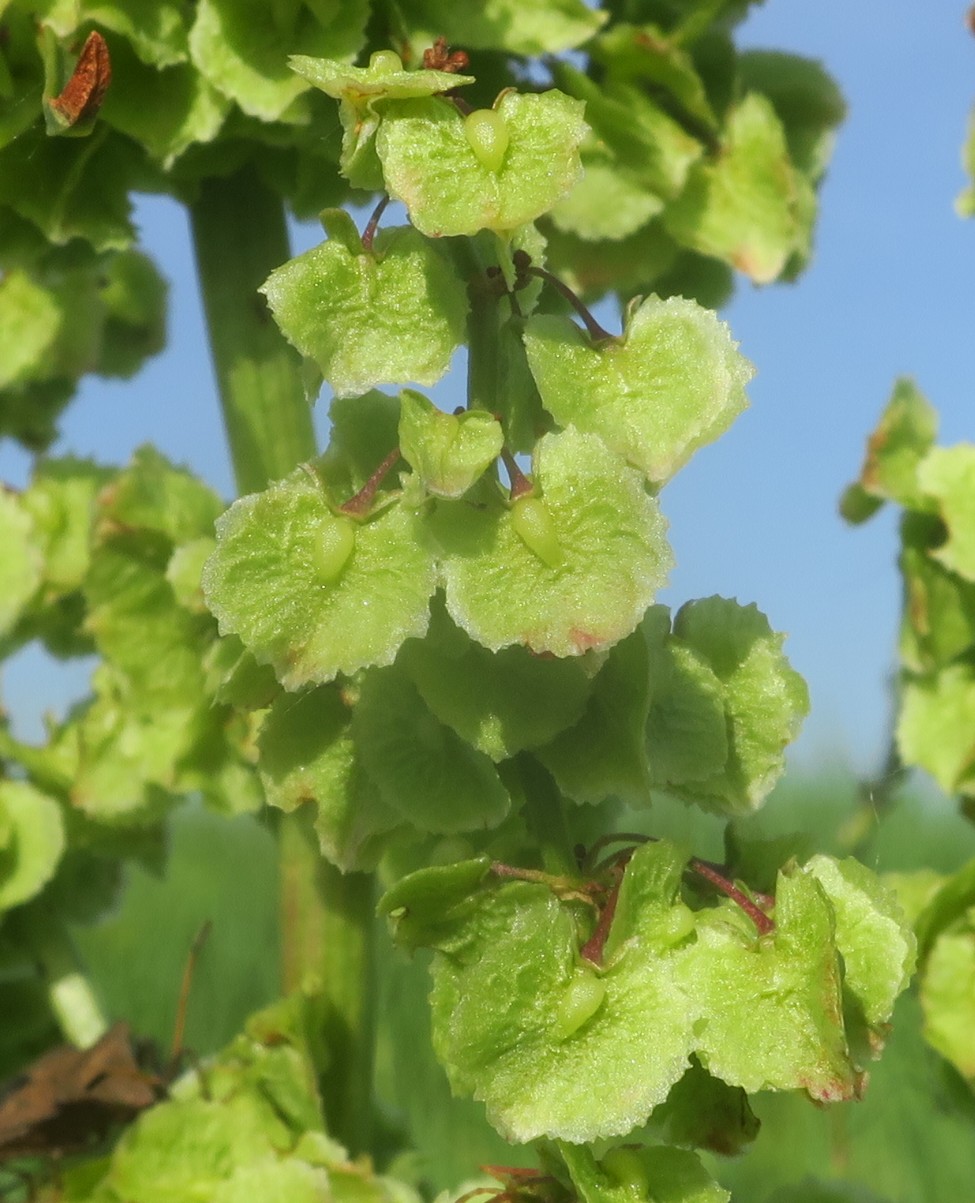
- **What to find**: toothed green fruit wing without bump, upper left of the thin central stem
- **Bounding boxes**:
[261,212,467,396]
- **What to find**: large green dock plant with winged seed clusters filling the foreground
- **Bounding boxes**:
[0,0,914,1203]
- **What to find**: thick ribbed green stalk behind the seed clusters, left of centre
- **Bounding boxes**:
[190,168,374,1154]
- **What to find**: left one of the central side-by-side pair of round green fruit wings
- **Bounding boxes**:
[203,468,435,689]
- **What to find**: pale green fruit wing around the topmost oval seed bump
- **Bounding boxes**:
[376,91,586,238]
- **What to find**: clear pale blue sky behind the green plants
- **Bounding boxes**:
[0,0,975,772]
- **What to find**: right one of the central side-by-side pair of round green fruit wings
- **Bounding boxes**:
[432,429,672,656]
